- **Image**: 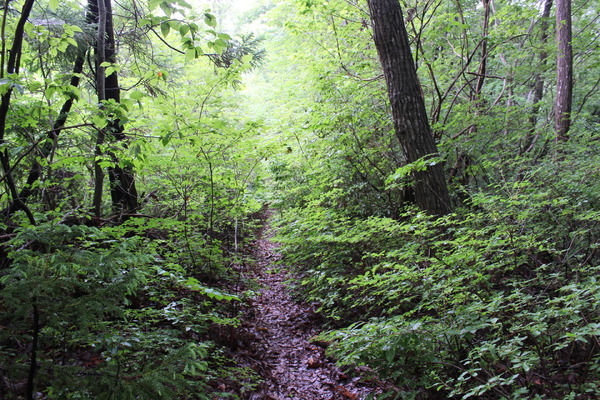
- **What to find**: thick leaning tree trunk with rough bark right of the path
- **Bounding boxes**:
[368,0,451,215]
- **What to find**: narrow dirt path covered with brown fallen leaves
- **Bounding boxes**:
[236,222,380,400]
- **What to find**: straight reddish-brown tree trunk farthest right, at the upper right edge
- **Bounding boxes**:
[554,0,573,141]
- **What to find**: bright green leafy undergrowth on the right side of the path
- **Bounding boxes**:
[277,162,600,399]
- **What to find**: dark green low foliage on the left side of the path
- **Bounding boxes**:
[0,223,251,399]
